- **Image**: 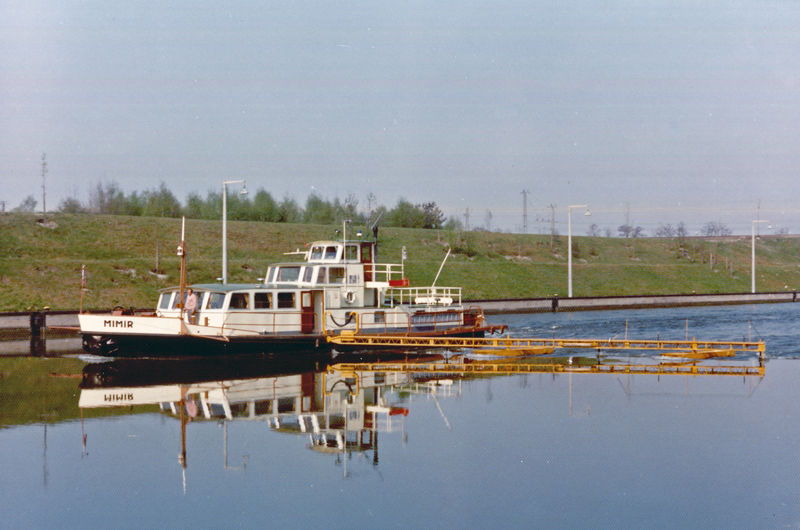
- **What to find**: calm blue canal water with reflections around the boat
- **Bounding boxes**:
[0,304,800,529]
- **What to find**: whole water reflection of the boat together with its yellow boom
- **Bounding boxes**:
[79,355,764,477]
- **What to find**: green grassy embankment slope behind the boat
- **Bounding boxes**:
[0,209,800,311]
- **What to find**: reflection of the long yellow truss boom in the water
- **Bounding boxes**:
[328,361,764,377]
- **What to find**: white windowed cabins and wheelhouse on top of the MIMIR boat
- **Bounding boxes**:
[151,241,461,334]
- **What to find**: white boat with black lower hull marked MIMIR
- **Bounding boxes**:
[79,235,505,356]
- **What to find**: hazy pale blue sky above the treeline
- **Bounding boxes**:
[0,0,800,234]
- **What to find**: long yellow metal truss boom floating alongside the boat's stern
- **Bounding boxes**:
[328,332,765,358]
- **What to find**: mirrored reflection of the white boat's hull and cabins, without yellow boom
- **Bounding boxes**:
[79,357,450,463]
